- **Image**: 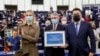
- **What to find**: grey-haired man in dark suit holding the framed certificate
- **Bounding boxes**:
[45,12,65,56]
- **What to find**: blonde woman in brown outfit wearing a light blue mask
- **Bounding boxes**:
[15,10,40,56]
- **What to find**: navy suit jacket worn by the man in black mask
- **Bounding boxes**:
[66,21,96,56]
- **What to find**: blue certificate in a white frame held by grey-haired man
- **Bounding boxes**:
[44,31,65,47]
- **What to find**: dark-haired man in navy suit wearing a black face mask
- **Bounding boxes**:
[66,8,96,56]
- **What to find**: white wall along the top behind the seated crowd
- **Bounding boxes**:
[0,0,100,11]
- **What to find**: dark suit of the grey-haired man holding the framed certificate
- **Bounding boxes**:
[45,24,65,56]
